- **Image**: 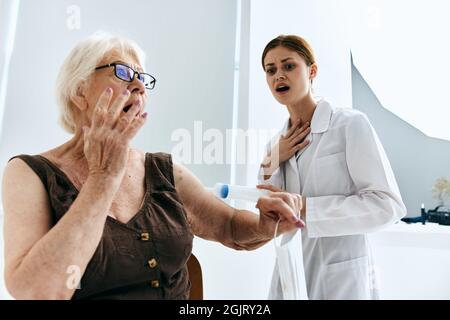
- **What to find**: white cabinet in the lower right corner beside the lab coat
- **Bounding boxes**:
[370,222,450,299]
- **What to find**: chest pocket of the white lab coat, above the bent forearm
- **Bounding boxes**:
[314,152,351,196]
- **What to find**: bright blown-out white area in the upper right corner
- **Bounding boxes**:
[345,0,450,140]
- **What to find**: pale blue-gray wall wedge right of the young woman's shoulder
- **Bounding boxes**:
[352,62,450,217]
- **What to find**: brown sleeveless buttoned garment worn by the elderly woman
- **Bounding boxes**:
[12,153,193,299]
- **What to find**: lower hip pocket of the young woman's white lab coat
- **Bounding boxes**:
[325,256,371,300]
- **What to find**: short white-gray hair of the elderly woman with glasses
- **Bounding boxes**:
[56,31,145,133]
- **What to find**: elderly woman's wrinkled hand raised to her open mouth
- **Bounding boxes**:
[83,88,147,180]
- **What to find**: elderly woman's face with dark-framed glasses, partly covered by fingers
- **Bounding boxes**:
[84,52,147,125]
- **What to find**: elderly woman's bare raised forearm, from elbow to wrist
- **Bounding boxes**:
[9,177,118,299]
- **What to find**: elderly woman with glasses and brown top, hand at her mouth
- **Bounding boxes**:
[3,34,304,299]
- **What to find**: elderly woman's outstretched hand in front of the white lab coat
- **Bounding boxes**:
[256,185,305,238]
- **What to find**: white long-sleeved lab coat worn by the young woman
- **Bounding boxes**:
[258,100,406,299]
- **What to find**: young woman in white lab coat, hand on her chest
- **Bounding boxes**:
[260,35,406,299]
